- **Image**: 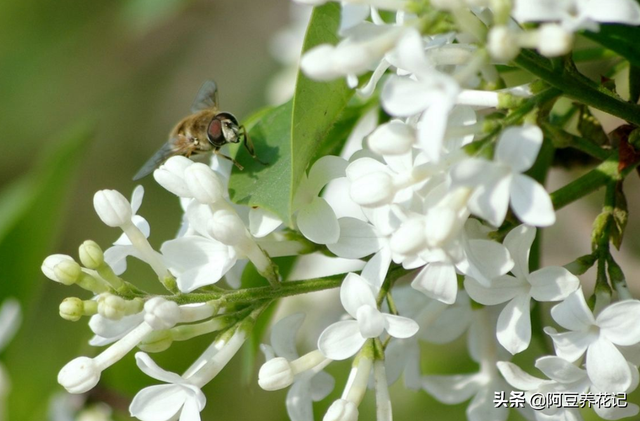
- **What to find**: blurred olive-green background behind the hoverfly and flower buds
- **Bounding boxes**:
[0,0,637,421]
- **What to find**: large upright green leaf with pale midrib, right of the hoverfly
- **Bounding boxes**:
[229,3,353,226]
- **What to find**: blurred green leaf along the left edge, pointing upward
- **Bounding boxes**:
[0,124,91,420]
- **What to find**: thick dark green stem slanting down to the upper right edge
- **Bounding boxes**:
[514,50,640,125]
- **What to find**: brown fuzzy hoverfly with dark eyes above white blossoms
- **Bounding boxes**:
[133,80,266,180]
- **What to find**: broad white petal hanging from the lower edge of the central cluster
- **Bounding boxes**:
[411,262,458,304]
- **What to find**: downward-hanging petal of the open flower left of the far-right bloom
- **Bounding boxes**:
[496,294,531,355]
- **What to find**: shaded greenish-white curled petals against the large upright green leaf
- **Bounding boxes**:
[293,155,348,244]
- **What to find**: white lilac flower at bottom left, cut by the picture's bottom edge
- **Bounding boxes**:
[129,352,207,421]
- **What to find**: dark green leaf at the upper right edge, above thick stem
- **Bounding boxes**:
[583,24,640,66]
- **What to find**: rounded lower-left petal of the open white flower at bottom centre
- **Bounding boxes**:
[318,320,367,360]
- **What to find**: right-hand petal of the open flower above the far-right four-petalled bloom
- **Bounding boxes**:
[528,266,580,301]
